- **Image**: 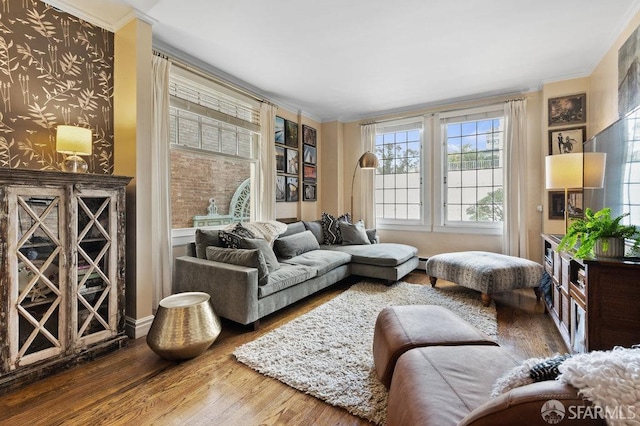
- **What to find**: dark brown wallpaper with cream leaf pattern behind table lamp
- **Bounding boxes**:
[0,0,114,174]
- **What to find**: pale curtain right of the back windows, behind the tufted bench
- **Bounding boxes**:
[502,99,528,258]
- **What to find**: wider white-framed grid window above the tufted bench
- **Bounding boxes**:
[440,108,504,227]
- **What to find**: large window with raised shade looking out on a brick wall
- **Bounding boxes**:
[169,67,260,229]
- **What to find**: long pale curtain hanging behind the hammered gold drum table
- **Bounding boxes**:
[149,55,172,309]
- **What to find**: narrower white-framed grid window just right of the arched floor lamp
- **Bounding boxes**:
[375,118,424,224]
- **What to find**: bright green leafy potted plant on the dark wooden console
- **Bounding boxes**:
[558,207,640,259]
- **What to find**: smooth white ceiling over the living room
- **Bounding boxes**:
[48,0,640,121]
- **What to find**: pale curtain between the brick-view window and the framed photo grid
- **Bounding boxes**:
[252,102,277,221]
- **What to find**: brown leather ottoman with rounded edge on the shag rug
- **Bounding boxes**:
[373,305,497,387]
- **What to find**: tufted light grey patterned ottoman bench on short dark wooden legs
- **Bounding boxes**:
[426,251,543,305]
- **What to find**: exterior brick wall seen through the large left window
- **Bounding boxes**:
[171,149,250,228]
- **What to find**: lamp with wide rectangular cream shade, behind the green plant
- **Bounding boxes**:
[545,152,607,233]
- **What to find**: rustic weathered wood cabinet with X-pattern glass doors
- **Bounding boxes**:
[0,169,130,390]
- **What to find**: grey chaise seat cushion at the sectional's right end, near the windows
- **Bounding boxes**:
[321,243,418,266]
